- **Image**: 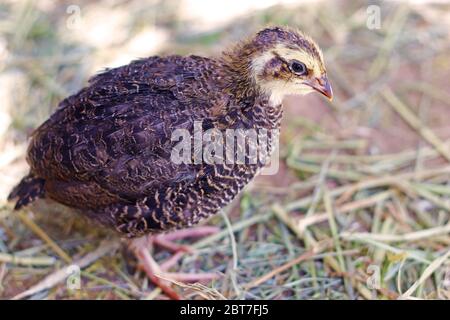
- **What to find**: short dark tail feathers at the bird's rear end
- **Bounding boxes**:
[8,174,45,210]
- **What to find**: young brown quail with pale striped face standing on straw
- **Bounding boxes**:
[8,26,333,299]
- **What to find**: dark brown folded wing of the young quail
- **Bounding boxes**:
[28,56,227,198]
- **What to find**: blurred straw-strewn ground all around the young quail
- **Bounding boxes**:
[0,0,450,299]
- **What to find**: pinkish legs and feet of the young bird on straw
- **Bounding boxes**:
[131,227,218,300]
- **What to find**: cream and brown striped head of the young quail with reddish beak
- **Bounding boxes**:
[224,27,333,103]
